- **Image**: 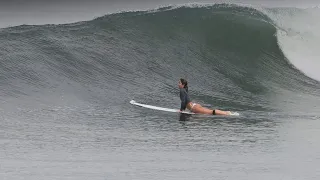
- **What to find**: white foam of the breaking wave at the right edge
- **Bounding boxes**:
[265,7,320,81]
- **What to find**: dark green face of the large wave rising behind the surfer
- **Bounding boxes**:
[0,4,320,115]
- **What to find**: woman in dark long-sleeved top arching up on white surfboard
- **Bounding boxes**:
[179,79,231,115]
